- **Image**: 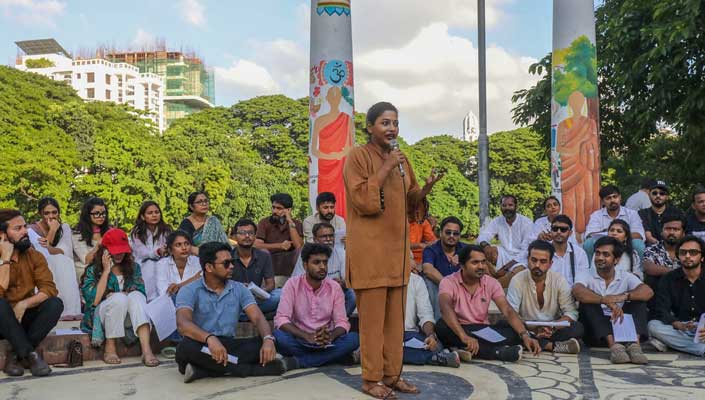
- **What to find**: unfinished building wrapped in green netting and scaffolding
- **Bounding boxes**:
[104,50,215,125]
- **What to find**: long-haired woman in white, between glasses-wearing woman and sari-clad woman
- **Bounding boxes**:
[130,200,172,301]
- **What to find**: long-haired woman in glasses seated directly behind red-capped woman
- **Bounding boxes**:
[71,197,110,280]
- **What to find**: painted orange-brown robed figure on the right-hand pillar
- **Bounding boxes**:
[556,91,600,233]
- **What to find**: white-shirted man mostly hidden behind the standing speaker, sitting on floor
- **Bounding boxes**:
[404,273,460,368]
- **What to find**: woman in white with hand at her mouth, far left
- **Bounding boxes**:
[29,197,81,320]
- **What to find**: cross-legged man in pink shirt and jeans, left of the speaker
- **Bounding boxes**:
[274,243,360,368]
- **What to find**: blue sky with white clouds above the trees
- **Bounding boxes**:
[0,0,552,142]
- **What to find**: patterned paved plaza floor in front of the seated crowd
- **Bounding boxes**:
[0,349,705,400]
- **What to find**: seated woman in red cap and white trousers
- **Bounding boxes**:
[81,228,159,367]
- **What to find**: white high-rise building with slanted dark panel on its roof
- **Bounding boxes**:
[15,39,166,132]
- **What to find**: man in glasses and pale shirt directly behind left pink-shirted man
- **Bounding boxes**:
[291,222,355,316]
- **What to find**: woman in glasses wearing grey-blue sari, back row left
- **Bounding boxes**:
[179,191,229,256]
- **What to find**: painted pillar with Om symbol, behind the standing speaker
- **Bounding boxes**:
[309,0,355,218]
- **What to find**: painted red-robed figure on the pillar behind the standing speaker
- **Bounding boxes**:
[312,86,353,218]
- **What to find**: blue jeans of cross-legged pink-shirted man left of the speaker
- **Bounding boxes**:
[274,329,360,368]
